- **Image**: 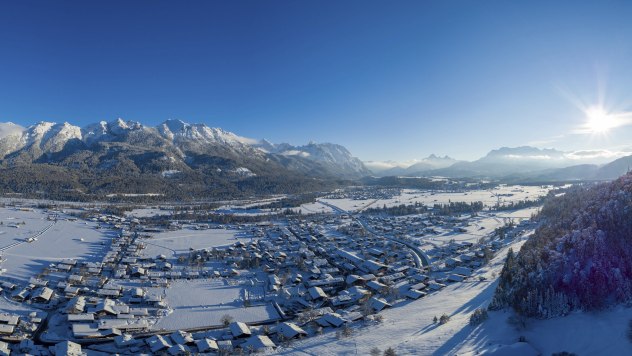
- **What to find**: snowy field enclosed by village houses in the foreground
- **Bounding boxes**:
[153,279,279,330]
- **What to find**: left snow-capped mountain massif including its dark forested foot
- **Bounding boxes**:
[0,119,370,202]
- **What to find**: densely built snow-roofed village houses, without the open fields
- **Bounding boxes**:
[0,195,532,355]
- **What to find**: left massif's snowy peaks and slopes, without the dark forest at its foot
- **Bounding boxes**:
[0,119,368,178]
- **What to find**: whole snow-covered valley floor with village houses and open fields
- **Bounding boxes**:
[0,186,559,355]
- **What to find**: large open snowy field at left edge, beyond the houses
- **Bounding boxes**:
[0,208,115,281]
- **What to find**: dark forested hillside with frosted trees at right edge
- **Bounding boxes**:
[490,174,632,318]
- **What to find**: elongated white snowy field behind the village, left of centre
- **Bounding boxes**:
[142,227,251,257]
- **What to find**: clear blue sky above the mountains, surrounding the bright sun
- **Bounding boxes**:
[0,0,632,160]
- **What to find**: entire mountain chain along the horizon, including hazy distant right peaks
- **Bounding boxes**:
[0,119,632,199]
